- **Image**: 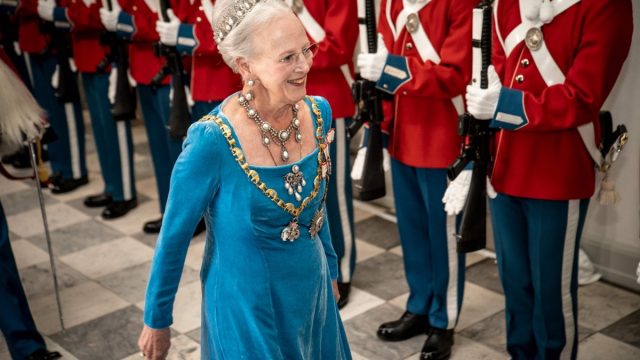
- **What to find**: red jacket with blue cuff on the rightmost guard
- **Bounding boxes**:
[491,0,633,200]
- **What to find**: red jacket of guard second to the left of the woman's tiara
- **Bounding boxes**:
[117,0,170,85]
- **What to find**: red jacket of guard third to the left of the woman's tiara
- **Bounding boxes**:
[54,0,109,73]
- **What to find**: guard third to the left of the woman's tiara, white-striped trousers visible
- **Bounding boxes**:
[38,0,137,219]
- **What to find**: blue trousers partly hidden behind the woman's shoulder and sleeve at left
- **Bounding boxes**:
[137,84,182,214]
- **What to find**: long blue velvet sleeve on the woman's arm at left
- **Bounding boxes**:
[144,122,221,329]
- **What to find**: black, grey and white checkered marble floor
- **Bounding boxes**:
[0,119,640,360]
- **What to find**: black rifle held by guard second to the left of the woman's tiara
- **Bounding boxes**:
[104,0,136,121]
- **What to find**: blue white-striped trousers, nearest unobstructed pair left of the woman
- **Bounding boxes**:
[82,73,136,201]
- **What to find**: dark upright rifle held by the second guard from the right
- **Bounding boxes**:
[347,0,386,201]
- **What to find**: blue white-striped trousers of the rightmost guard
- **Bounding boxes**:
[489,194,589,360]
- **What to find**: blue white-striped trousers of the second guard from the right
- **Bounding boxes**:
[391,158,465,329]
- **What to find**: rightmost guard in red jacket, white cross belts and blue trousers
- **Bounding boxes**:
[456,0,633,359]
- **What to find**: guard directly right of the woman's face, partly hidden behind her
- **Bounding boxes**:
[286,0,358,308]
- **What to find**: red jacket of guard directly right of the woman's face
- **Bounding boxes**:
[292,0,358,119]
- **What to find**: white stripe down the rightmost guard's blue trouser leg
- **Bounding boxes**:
[560,200,580,359]
